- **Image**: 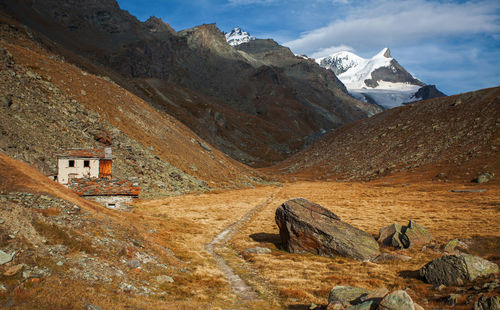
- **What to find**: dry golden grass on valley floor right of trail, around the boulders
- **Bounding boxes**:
[225,182,500,306]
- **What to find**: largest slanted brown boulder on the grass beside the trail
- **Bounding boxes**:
[275,198,380,260]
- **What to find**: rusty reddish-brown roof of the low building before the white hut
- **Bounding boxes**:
[68,178,141,196]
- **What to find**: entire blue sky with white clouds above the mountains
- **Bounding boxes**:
[118,0,500,94]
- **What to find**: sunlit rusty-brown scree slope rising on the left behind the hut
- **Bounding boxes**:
[0,18,268,196]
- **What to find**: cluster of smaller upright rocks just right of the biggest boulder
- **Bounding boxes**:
[378,220,432,249]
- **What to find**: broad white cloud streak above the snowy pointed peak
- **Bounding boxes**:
[286,0,500,55]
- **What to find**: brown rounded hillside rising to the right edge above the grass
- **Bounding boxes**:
[274,87,500,182]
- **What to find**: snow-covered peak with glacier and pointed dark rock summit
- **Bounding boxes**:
[316,48,444,108]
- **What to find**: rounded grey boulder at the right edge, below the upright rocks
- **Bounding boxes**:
[420,254,499,285]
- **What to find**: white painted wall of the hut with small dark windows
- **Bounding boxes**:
[57,158,99,185]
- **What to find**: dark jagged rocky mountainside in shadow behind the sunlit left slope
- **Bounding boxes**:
[1,0,380,166]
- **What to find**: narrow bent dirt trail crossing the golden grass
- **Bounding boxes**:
[205,192,277,300]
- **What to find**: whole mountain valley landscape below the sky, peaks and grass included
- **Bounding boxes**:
[0,0,500,310]
